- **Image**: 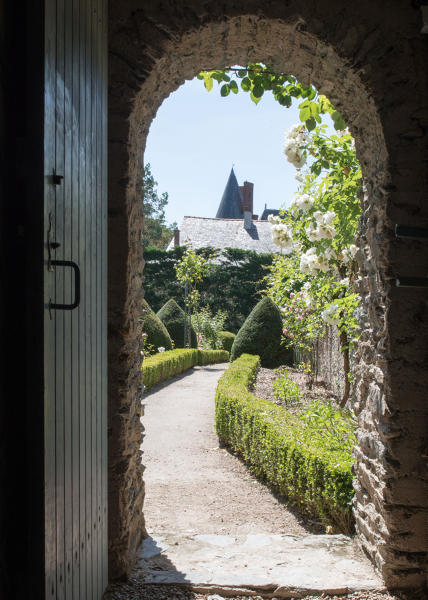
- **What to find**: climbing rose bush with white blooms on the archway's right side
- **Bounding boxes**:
[266,126,361,349]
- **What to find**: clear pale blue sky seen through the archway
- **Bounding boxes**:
[144,79,299,223]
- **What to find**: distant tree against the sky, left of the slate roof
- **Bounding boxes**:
[142,163,176,248]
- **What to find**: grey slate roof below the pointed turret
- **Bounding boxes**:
[167,217,279,254]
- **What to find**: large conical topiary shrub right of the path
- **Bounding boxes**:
[230,297,290,367]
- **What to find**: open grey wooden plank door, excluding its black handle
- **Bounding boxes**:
[45,0,107,600]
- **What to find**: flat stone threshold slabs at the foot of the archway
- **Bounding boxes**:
[136,533,385,598]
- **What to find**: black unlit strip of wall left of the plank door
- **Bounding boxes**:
[0,0,44,599]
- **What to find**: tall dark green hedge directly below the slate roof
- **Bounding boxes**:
[144,246,272,332]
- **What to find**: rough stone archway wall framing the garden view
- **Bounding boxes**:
[105,0,428,588]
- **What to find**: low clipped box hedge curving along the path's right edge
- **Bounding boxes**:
[215,354,354,533]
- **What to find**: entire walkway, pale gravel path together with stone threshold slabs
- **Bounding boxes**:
[128,365,382,598]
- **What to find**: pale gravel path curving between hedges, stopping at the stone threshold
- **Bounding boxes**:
[143,364,312,535]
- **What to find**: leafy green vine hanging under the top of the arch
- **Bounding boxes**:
[198,63,345,131]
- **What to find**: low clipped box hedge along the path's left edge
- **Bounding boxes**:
[142,348,229,391]
